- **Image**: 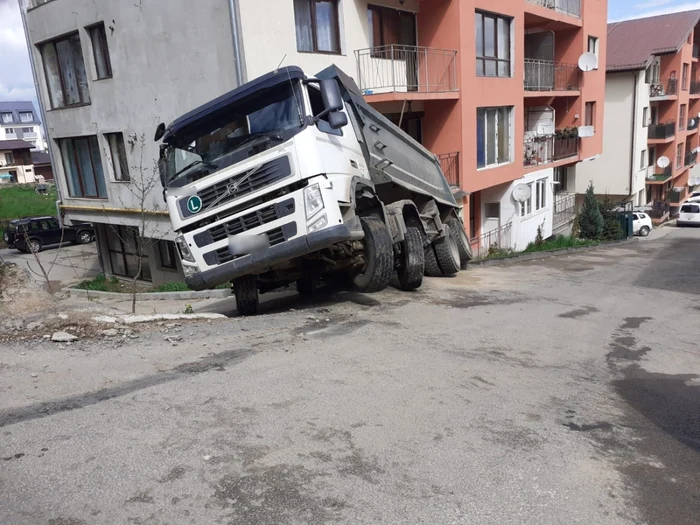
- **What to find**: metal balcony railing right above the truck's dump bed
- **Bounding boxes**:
[355,45,457,95]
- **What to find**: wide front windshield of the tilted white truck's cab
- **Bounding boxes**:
[165,82,303,186]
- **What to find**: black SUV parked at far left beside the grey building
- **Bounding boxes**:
[3,217,95,252]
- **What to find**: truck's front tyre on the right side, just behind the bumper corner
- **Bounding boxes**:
[352,217,394,293]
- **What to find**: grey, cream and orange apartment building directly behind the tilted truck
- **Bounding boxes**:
[25,0,607,282]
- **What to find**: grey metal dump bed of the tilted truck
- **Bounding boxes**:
[316,66,457,207]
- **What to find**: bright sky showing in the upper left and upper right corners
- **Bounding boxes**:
[0,0,700,109]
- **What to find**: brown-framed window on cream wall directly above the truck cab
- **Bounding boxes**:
[294,0,340,54]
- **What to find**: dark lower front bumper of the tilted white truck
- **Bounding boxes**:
[185,218,364,290]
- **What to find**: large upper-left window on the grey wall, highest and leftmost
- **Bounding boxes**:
[40,33,90,109]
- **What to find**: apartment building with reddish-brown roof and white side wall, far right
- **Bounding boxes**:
[576,11,700,222]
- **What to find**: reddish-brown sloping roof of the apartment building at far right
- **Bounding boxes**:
[606,10,700,71]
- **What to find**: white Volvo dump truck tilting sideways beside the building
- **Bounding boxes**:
[155,66,471,315]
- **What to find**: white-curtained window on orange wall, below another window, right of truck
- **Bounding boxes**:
[476,107,513,168]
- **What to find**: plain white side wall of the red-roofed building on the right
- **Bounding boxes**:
[575,71,649,204]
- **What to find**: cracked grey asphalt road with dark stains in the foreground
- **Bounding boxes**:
[0,229,700,525]
